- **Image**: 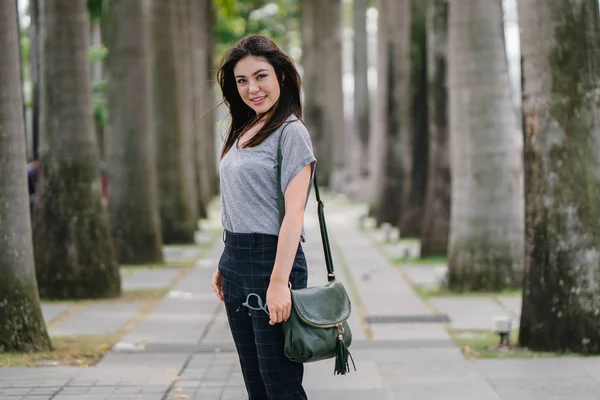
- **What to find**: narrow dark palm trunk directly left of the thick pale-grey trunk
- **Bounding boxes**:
[421,0,450,257]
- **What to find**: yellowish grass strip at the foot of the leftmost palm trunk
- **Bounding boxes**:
[0,335,119,368]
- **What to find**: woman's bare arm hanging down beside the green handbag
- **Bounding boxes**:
[266,164,312,325]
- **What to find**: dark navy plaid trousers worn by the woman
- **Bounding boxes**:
[219,231,308,400]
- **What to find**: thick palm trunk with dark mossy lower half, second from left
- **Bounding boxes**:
[34,0,121,298]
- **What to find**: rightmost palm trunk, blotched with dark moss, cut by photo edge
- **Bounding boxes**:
[518,0,600,354]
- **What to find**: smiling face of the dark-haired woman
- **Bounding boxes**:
[233,56,281,114]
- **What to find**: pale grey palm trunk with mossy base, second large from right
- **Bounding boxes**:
[448,0,524,290]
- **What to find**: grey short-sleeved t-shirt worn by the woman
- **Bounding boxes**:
[219,116,316,240]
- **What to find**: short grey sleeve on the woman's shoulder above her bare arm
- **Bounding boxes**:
[281,121,317,193]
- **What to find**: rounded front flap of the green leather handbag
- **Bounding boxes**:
[292,281,351,327]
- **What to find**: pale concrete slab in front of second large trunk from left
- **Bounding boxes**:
[50,302,142,335]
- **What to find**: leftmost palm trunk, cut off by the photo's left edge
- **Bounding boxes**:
[0,1,51,353]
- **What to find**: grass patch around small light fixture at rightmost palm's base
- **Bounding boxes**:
[451,330,580,360]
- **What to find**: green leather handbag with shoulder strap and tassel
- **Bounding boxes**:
[278,134,356,375]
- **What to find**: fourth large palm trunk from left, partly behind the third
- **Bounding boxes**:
[151,0,196,243]
